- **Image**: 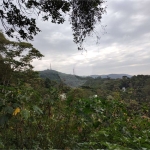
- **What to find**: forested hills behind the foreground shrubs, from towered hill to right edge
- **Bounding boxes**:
[40,70,150,102]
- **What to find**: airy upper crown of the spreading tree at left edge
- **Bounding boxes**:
[0,32,43,71]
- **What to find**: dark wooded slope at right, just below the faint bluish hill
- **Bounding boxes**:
[82,75,150,102]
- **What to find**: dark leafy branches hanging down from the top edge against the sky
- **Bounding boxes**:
[0,0,106,49]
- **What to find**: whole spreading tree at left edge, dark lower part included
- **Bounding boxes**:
[0,32,43,85]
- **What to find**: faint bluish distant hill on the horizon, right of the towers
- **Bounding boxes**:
[90,74,132,79]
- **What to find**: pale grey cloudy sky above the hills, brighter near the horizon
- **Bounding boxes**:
[19,0,150,75]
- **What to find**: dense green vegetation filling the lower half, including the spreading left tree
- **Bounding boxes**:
[0,33,150,150]
